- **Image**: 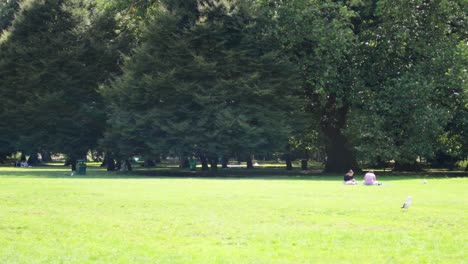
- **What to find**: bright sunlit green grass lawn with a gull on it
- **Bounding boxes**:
[0,167,468,263]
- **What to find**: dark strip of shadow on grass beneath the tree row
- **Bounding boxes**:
[0,166,468,181]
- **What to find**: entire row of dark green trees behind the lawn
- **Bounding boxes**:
[0,0,468,172]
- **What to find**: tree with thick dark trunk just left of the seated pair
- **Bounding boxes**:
[262,0,357,172]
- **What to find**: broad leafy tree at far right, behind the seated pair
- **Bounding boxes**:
[347,0,466,169]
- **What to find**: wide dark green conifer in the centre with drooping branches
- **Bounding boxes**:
[105,1,297,170]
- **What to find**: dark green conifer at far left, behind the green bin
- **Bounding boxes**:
[0,0,118,167]
